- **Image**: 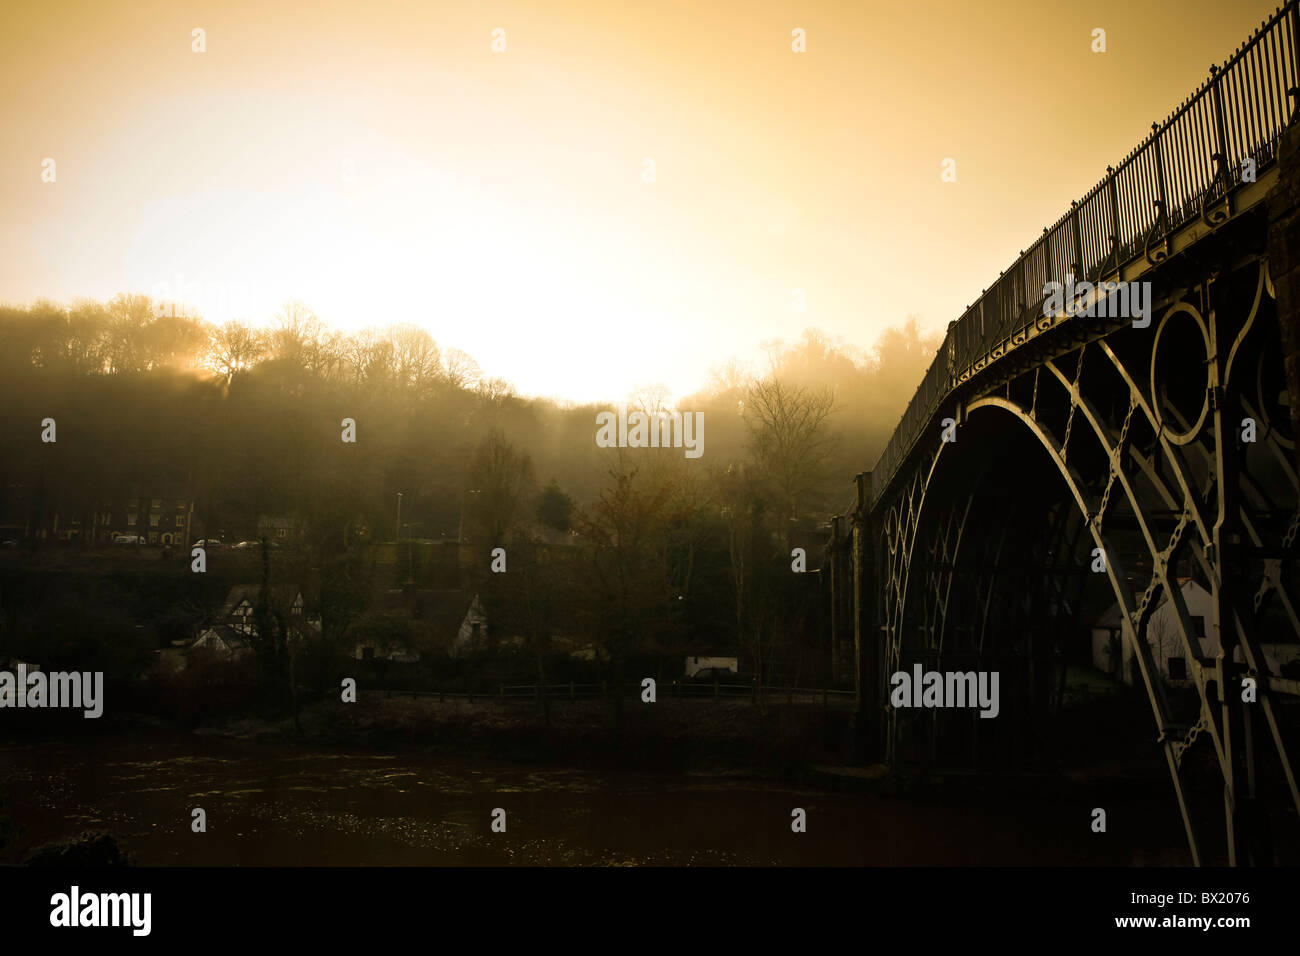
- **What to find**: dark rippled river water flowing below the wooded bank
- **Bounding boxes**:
[0,734,1182,866]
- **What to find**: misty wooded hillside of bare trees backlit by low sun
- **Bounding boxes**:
[0,295,939,700]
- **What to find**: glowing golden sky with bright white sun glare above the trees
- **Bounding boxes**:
[0,0,1274,401]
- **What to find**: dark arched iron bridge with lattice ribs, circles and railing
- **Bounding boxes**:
[823,0,1300,865]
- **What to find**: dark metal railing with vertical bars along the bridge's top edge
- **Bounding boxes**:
[871,0,1300,505]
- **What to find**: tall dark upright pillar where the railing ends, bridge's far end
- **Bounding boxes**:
[852,472,880,760]
